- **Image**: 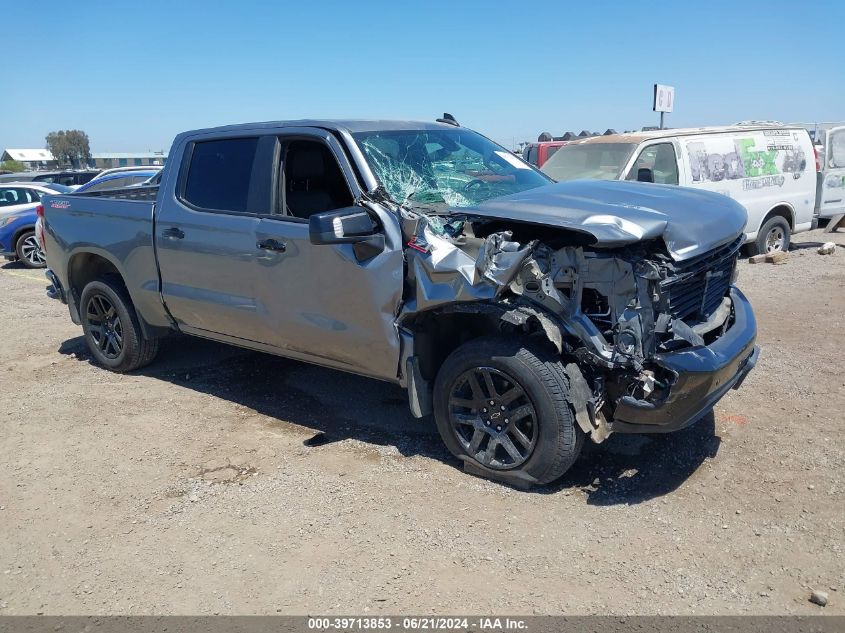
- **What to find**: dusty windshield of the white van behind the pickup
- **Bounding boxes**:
[542,143,637,182]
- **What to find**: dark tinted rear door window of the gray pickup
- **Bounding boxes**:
[182,137,258,213]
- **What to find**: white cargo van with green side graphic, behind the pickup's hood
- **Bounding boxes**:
[542,124,817,252]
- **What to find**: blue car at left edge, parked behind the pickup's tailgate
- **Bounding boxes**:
[0,182,73,268]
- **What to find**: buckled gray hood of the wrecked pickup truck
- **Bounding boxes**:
[462,180,747,261]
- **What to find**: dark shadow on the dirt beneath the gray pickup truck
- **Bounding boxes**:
[58,336,720,505]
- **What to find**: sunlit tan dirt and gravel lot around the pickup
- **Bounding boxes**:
[0,231,845,615]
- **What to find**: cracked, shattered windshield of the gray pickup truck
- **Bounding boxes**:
[353,128,549,207]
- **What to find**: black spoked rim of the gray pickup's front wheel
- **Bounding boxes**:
[449,367,539,470]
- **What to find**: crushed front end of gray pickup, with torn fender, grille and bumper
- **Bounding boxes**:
[397,209,757,442]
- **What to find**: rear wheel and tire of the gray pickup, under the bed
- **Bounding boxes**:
[79,277,159,373]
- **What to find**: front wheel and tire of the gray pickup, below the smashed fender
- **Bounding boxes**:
[434,337,584,484]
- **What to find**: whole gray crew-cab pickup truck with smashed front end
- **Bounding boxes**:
[43,118,757,486]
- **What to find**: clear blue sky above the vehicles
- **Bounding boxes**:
[0,0,845,152]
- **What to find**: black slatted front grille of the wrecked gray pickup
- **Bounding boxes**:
[661,236,743,320]
